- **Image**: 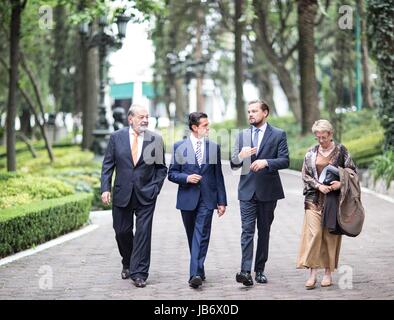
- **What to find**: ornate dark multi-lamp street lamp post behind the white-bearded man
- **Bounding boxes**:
[80,15,129,156]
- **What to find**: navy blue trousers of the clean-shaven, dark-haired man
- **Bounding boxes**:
[181,198,213,278]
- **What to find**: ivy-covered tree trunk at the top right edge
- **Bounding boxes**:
[368,0,394,150]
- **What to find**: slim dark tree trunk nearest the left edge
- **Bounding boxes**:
[6,0,26,171]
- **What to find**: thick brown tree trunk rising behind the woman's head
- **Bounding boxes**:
[298,0,320,134]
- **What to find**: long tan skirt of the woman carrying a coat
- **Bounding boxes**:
[297,207,342,271]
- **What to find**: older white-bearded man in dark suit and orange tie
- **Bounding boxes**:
[101,105,167,288]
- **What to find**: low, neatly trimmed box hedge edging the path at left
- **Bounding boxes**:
[0,193,92,257]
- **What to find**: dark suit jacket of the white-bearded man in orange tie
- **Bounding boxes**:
[101,127,167,207]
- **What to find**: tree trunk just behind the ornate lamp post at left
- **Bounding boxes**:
[82,37,99,149]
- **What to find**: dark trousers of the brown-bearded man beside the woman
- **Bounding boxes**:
[240,195,277,272]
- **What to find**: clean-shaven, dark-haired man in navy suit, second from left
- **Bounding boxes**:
[168,112,227,289]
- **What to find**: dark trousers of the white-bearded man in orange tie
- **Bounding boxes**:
[112,193,156,280]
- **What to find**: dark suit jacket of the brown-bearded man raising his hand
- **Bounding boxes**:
[231,124,289,201]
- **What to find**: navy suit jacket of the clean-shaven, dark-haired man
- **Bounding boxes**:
[168,138,227,211]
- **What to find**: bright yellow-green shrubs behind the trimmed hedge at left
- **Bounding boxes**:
[0,146,101,208]
